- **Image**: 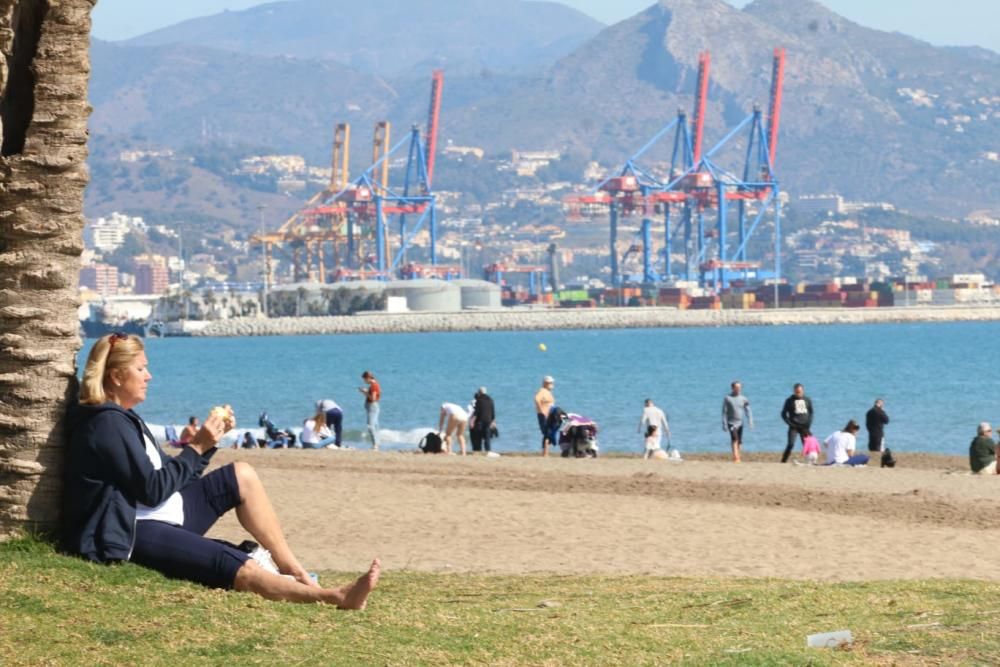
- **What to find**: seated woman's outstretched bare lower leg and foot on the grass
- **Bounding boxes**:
[233,559,382,609]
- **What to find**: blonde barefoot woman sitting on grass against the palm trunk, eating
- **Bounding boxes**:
[63,333,380,609]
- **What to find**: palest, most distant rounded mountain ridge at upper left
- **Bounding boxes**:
[117,0,604,76]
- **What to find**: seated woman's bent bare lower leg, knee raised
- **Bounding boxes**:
[233,461,317,587]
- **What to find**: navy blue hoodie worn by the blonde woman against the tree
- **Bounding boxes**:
[62,402,215,563]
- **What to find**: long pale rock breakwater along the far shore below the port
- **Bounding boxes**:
[194,306,1000,336]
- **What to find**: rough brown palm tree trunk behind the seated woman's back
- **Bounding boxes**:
[0,0,94,539]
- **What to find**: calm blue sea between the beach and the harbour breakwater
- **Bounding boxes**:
[81,323,1000,454]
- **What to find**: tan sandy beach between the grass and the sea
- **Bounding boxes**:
[203,450,1000,581]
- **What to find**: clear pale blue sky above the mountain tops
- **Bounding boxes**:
[94,0,1000,52]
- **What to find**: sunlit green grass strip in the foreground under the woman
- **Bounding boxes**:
[0,538,1000,666]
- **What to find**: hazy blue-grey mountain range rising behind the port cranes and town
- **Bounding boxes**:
[91,0,1000,217]
